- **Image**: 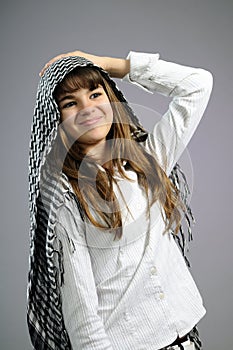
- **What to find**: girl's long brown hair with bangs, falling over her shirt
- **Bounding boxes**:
[51,67,181,238]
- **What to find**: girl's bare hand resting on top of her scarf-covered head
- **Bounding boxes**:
[39,51,108,76]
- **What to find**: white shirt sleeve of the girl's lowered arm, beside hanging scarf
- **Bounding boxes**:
[55,194,112,350]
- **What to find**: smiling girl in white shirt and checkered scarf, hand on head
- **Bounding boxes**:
[28,51,212,350]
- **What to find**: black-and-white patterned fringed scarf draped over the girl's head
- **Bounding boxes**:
[27,56,197,350]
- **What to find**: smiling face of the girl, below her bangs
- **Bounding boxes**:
[58,85,113,152]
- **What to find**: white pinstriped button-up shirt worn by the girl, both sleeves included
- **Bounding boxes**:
[56,52,212,350]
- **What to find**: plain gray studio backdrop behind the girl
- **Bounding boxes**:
[0,0,233,350]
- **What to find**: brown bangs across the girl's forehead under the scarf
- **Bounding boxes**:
[53,67,105,100]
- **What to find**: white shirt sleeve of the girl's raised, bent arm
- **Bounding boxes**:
[123,52,213,175]
